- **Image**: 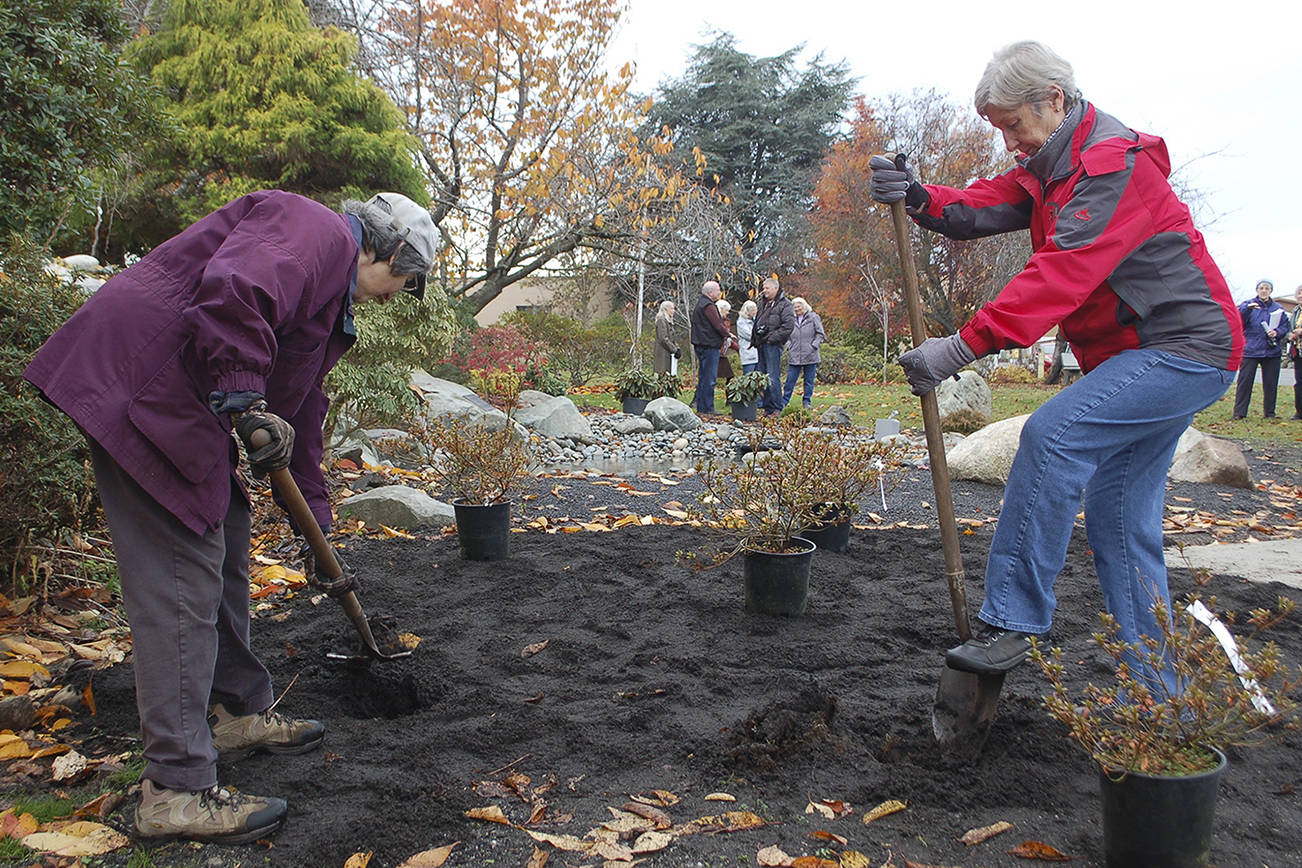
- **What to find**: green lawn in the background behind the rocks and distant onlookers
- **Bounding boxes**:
[570,383,1302,442]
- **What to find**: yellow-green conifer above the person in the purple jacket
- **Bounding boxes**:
[115,0,427,255]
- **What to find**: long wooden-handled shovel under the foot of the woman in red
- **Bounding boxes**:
[891,154,1004,760]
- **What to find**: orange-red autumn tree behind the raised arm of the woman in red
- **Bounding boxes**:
[806,91,1030,334]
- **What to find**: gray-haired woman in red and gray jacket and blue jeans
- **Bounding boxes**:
[871,42,1243,687]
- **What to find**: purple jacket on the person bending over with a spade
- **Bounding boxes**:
[23,190,358,534]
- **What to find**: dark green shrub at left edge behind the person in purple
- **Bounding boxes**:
[0,237,98,590]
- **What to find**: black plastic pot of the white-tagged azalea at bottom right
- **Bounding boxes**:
[1099,751,1225,868]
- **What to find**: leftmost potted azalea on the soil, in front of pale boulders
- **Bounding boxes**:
[419,380,536,561]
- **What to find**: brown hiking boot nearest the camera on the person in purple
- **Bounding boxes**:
[135,778,289,843]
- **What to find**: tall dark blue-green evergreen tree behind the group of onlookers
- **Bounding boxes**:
[644,34,853,284]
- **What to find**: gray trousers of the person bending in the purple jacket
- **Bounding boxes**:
[90,441,275,790]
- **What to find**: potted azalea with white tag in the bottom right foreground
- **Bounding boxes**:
[1031,596,1302,868]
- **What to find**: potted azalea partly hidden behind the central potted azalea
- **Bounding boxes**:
[798,428,902,552]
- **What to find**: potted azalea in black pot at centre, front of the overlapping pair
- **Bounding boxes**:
[680,420,818,616]
